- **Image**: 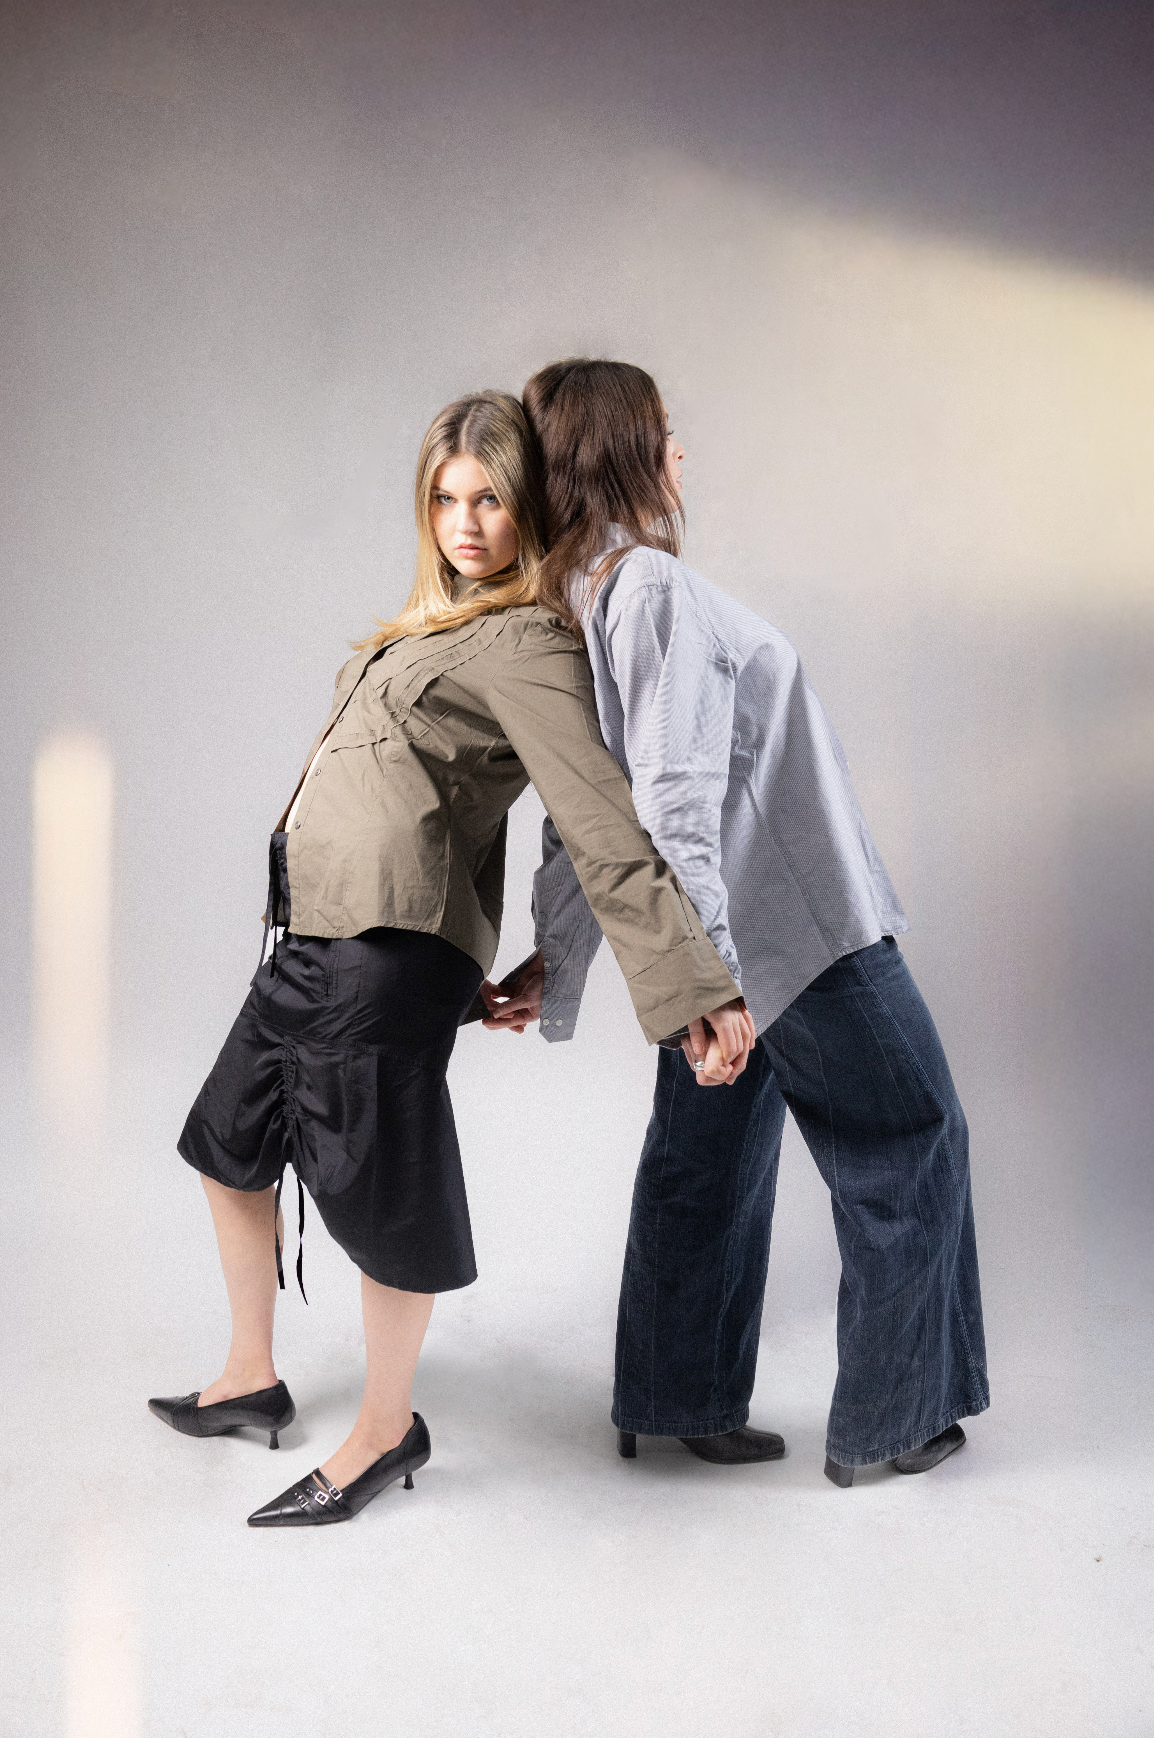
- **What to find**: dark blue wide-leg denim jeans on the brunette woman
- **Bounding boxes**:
[613,937,989,1467]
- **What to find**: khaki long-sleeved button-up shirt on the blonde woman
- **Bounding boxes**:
[274,607,739,1043]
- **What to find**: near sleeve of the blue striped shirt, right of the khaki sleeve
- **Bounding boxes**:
[605,563,740,982]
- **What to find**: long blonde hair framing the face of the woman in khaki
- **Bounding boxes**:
[356,393,546,650]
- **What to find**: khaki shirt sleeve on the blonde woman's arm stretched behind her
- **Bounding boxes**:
[488,624,737,1043]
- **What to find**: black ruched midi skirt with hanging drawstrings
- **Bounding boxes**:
[177,930,481,1291]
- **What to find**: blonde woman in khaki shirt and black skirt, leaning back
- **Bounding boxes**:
[149,393,751,1526]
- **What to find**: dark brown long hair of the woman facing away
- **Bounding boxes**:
[523,356,685,634]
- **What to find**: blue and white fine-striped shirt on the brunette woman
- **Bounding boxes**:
[534,549,909,1041]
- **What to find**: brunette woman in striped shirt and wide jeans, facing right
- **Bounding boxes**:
[487,360,989,1486]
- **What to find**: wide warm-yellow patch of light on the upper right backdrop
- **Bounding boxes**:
[612,156,1154,617]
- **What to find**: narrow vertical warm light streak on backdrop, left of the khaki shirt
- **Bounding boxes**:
[33,733,113,1123]
